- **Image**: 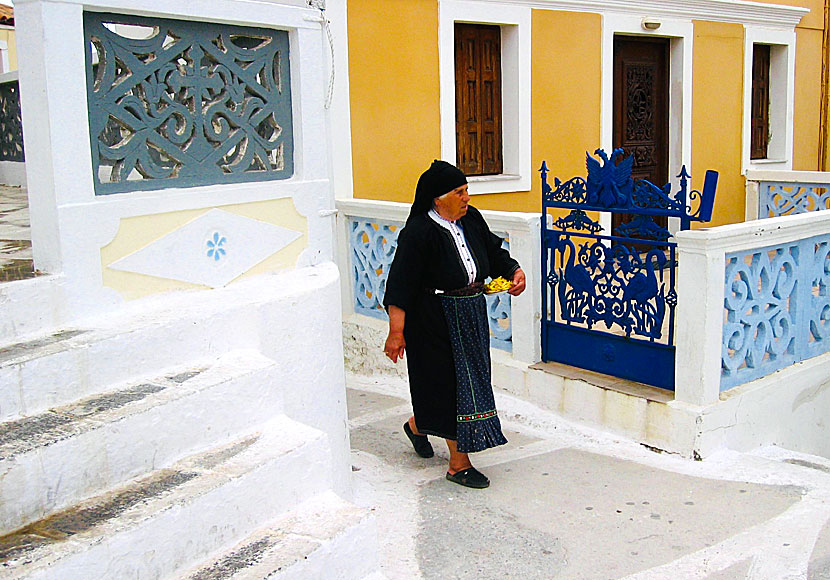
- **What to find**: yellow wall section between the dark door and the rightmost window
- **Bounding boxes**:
[692,21,746,225]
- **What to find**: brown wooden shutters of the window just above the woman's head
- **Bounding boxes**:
[455,24,503,175]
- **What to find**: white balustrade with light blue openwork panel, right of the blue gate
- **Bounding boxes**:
[675,212,830,405]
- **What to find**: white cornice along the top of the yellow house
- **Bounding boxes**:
[468,0,810,28]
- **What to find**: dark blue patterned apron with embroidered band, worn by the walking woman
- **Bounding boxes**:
[441,294,507,453]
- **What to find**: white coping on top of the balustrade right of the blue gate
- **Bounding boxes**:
[675,210,830,254]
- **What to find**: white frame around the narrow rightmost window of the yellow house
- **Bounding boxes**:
[741,26,795,174]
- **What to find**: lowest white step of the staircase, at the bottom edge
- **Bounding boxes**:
[180,492,381,580]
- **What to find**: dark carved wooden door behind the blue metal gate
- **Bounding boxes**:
[612,36,669,236]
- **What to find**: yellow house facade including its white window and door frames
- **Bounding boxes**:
[347,0,828,225]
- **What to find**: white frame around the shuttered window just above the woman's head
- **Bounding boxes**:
[438,0,533,195]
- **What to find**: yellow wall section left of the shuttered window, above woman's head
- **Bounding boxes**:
[348,0,452,202]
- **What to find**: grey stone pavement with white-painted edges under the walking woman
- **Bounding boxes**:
[347,375,830,580]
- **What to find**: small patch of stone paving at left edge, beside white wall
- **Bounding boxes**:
[0,185,35,282]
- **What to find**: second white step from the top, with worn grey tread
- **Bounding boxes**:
[0,350,283,534]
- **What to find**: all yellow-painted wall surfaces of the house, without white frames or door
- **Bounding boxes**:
[348,0,824,225]
